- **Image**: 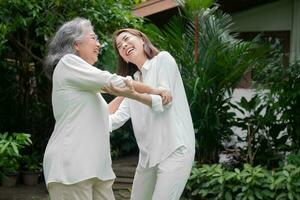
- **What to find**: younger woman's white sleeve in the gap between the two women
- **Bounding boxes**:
[109,98,131,131]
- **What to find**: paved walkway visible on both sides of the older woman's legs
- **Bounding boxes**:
[0,156,137,200]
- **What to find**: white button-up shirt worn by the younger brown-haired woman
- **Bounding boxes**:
[110,51,195,167]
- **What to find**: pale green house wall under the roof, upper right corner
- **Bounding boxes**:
[232,0,300,62]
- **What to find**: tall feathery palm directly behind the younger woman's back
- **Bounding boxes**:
[143,0,268,163]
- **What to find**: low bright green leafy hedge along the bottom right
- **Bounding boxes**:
[185,164,300,200]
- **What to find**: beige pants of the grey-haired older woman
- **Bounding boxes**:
[48,178,115,200]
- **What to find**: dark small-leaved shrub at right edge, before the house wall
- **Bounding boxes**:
[255,59,300,153]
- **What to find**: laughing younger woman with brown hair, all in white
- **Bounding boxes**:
[109,29,195,200]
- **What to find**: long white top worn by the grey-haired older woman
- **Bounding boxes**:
[43,54,125,185]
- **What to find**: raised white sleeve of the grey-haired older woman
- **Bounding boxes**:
[61,54,125,91]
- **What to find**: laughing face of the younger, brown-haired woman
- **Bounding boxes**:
[116,32,145,64]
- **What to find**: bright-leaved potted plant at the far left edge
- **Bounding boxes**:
[0,132,32,187]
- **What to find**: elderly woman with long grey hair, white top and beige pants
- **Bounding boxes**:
[43,18,170,200]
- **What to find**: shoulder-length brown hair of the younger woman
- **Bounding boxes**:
[113,28,159,76]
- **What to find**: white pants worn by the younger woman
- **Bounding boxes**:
[131,147,194,200]
